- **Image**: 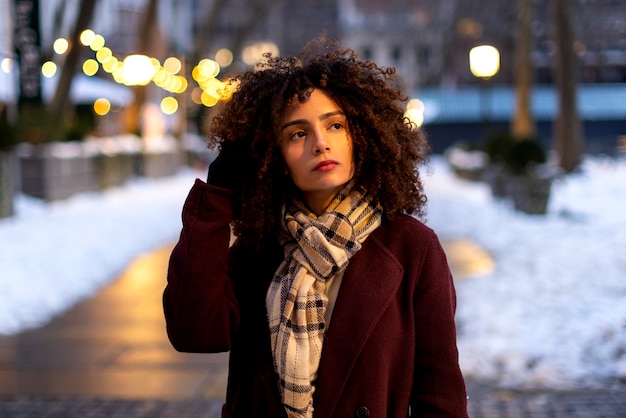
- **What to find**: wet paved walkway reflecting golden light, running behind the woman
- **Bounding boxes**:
[0,241,626,418]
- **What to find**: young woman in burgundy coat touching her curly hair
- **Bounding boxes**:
[163,39,467,418]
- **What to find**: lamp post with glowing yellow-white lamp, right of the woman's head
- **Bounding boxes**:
[469,45,500,135]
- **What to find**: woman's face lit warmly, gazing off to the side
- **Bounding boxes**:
[279,90,354,215]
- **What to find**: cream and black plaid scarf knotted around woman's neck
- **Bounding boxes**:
[266,187,382,417]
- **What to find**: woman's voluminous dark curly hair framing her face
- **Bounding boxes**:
[209,40,429,247]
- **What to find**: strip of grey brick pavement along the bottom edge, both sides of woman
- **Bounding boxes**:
[0,382,626,418]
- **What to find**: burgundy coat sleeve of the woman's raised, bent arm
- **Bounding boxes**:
[163,180,239,352]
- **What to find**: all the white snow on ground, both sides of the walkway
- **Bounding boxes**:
[0,157,626,388]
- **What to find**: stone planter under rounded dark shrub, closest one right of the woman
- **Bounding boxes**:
[507,175,552,215]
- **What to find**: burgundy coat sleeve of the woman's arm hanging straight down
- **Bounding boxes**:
[411,234,467,418]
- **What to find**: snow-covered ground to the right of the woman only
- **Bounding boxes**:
[427,158,626,388]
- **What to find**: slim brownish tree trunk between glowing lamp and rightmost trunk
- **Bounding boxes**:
[511,0,535,138]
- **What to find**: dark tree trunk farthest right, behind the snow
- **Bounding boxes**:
[552,0,583,173]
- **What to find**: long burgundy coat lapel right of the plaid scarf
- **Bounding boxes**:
[315,233,404,417]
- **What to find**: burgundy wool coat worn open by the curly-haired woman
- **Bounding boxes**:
[163,180,467,418]
